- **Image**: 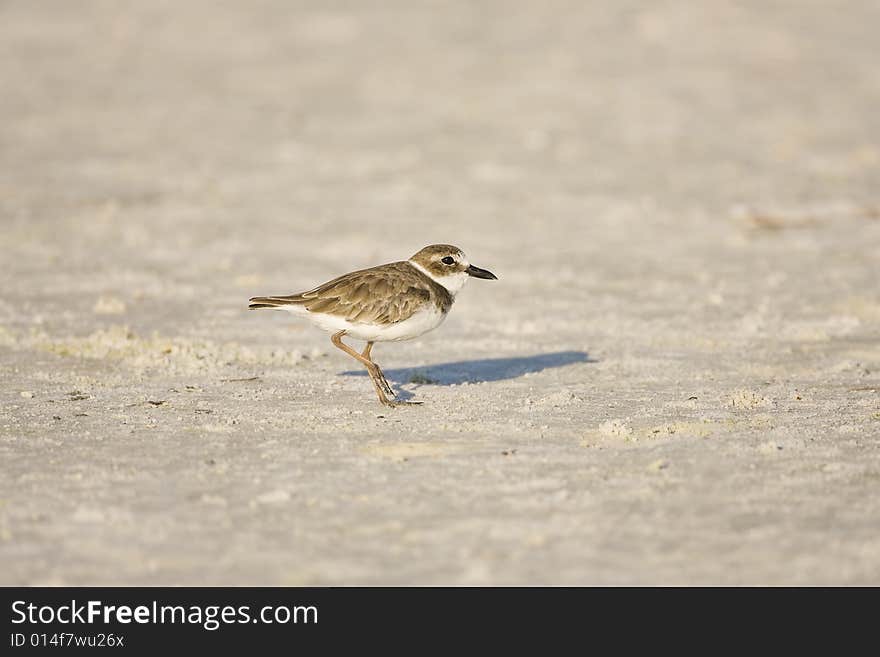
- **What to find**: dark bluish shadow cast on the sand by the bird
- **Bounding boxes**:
[342,351,598,400]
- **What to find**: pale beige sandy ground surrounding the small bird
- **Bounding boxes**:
[0,0,880,585]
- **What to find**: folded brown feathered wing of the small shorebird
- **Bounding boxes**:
[291,262,431,324]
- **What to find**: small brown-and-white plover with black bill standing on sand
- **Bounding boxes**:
[249,244,498,406]
